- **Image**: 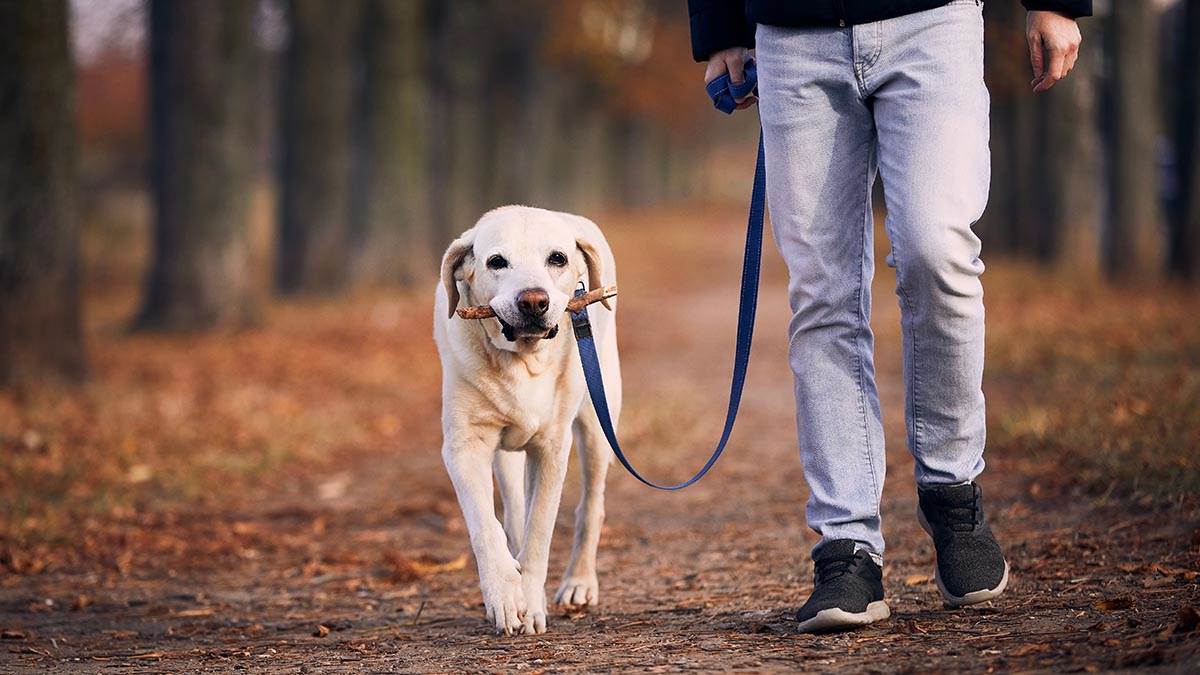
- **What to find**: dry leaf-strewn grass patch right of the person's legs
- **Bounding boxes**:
[986,264,1200,495]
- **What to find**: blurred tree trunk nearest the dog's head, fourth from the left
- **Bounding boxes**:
[350,0,434,283]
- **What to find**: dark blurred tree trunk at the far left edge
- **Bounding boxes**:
[0,0,85,384]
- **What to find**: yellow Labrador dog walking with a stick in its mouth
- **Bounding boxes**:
[433,207,620,634]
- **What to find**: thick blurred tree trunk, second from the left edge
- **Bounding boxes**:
[138,0,259,330]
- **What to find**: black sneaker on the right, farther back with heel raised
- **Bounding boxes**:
[917,483,1008,607]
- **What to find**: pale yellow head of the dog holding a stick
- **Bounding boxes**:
[442,207,602,351]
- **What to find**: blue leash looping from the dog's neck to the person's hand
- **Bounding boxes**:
[571,61,767,490]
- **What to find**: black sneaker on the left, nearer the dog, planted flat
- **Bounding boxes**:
[796,539,892,633]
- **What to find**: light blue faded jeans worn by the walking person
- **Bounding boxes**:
[756,0,991,556]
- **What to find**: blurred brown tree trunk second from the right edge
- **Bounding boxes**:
[1103,1,1163,280]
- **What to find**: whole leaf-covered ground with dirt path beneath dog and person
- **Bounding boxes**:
[0,209,1200,673]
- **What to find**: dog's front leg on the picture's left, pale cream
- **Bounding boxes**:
[442,438,527,635]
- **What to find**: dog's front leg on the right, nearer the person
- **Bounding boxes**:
[521,429,571,633]
